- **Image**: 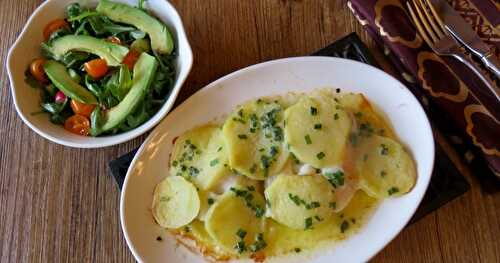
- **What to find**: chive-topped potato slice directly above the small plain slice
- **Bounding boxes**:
[170,124,230,190]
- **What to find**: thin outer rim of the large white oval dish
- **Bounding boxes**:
[120,56,435,262]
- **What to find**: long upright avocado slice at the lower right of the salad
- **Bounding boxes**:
[101,53,158,132]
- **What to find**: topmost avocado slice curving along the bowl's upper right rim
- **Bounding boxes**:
[96,0,174,54]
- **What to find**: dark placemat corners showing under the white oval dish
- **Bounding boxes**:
[109,33,470,223]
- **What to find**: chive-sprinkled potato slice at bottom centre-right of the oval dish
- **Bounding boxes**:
[265,174,335,229]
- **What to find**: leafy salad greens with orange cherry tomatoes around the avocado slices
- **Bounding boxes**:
[25,0,176,136]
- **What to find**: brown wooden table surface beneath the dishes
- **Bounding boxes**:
[0,0,500,262]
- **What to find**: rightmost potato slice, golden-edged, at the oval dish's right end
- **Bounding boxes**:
[356,135,417,198]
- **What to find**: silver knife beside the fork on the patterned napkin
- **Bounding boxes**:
[430,0,500,79]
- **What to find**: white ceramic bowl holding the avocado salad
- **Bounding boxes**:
[7,0,193,148]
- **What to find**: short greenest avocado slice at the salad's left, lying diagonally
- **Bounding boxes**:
[43,60,97,104]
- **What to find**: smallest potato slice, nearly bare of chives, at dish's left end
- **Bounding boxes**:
[152,176,200,228]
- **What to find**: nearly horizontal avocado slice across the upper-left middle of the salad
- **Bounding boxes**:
[49,35,128,67]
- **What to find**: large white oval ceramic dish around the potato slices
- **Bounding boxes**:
[120,57,434,263]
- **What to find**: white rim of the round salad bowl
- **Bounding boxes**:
[6,0,193,148]
